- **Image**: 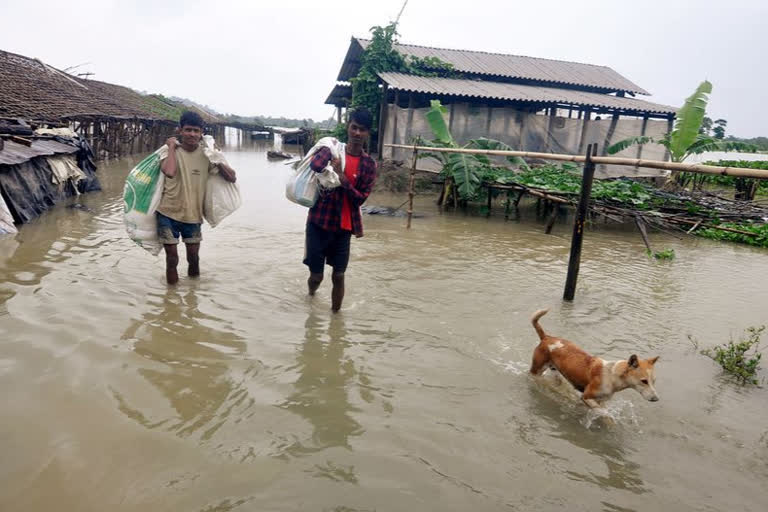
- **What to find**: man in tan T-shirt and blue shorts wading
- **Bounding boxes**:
[157,111,237,284]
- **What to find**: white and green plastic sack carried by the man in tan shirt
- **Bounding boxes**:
[123,146,168,255]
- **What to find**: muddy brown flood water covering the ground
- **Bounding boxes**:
[0,133,768,512]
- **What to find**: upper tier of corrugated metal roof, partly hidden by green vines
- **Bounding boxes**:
[337,37,650,95]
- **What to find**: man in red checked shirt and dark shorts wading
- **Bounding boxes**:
[304,109,376,313]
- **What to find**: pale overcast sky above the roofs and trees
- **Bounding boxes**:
[0,0,768,137]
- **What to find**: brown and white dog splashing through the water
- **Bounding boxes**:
[531,309,659,409]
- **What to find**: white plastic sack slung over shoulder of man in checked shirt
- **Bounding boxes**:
[285,137,345,208]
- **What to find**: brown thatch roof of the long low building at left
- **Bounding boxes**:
[0,50,220,123]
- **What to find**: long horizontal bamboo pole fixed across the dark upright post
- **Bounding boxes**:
[384,144,768,179]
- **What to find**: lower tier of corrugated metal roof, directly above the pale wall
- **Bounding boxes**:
[379,73,676,114]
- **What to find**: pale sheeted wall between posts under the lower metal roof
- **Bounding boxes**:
[383,103,668,178]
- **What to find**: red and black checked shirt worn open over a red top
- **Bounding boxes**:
[307,147,376,238]
